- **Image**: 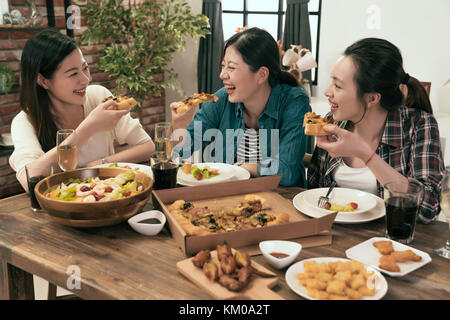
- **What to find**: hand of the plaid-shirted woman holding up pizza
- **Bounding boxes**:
[316,126,373,162]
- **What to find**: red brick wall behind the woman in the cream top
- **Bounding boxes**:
[0,0,165,199]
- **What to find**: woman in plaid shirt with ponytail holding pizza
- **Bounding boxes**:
[308,38,444,223]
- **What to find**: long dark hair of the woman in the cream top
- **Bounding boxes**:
[20,29,77,152]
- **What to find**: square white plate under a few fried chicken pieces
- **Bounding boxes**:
[345,237,431,277]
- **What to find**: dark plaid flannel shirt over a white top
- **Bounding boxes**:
[307,107,445,223]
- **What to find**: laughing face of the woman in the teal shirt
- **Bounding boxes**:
[220,46,261,104]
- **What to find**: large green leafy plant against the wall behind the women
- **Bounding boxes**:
[81,0,209,102]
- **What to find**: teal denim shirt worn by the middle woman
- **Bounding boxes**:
[174,84,311,187]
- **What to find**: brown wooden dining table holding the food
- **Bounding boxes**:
[0,187,450,300]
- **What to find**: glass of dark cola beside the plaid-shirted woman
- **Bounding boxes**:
[384,178,423,243]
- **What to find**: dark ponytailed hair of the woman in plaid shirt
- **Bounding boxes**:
[344,38,433,113]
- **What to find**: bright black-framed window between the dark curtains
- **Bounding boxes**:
[222,0,322,85]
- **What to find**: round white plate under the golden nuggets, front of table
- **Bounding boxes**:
[286,257,388,300]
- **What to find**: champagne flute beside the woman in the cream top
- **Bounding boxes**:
[56,129,78,171]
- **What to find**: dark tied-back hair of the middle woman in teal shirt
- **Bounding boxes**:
[222,28,298,88]
